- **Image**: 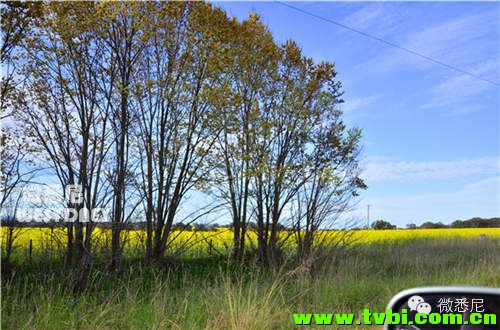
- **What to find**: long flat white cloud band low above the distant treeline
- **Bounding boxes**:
[364,157,500,182]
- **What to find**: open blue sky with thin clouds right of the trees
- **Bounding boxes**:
[214,2,500,228]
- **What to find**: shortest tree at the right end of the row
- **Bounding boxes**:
[294,107,367,261]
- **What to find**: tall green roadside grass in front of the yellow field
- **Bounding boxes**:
[1,239,500,329]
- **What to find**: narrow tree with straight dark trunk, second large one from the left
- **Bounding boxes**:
[94,2,147,270]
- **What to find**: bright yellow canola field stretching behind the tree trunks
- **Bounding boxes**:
[1,227,500,253]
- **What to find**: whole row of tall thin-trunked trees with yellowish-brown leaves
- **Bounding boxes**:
[2,2,366,286]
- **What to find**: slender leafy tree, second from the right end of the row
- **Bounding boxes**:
[248,41,325,265]
